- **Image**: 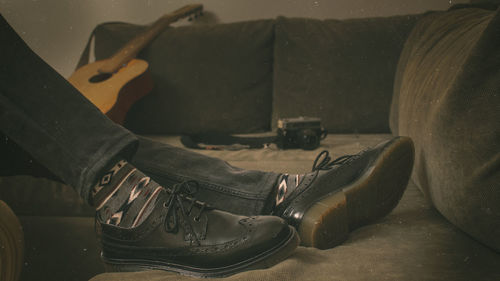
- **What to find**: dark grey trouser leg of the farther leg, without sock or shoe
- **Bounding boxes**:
[0,131,280,215]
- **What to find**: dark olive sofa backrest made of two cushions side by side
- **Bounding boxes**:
[87,16,418,134]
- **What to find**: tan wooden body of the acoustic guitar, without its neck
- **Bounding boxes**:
[68,59,153,125]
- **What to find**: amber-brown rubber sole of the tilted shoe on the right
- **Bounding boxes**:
[298,137,414,249]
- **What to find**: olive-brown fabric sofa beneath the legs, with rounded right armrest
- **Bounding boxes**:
[0,4,500,281]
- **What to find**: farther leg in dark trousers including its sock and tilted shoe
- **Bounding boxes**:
[132,137,414,249]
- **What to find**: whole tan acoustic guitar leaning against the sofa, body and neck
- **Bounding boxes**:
[68,4,203,124]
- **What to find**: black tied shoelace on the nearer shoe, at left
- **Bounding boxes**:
[163,180,209,245]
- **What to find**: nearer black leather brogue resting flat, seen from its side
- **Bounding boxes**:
[98,180,299,277]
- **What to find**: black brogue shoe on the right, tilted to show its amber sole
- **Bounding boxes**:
[272,137,414,249]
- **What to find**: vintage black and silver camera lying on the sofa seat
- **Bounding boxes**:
[276,117,327,150]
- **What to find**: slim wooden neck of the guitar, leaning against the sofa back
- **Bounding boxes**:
[99,4,203,73]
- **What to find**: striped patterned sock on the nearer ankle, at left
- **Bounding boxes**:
[91,160,163,228]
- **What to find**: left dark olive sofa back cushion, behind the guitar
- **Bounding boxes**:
[95,20,274,134]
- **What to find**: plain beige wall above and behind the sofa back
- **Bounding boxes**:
[0,0,469,77]
